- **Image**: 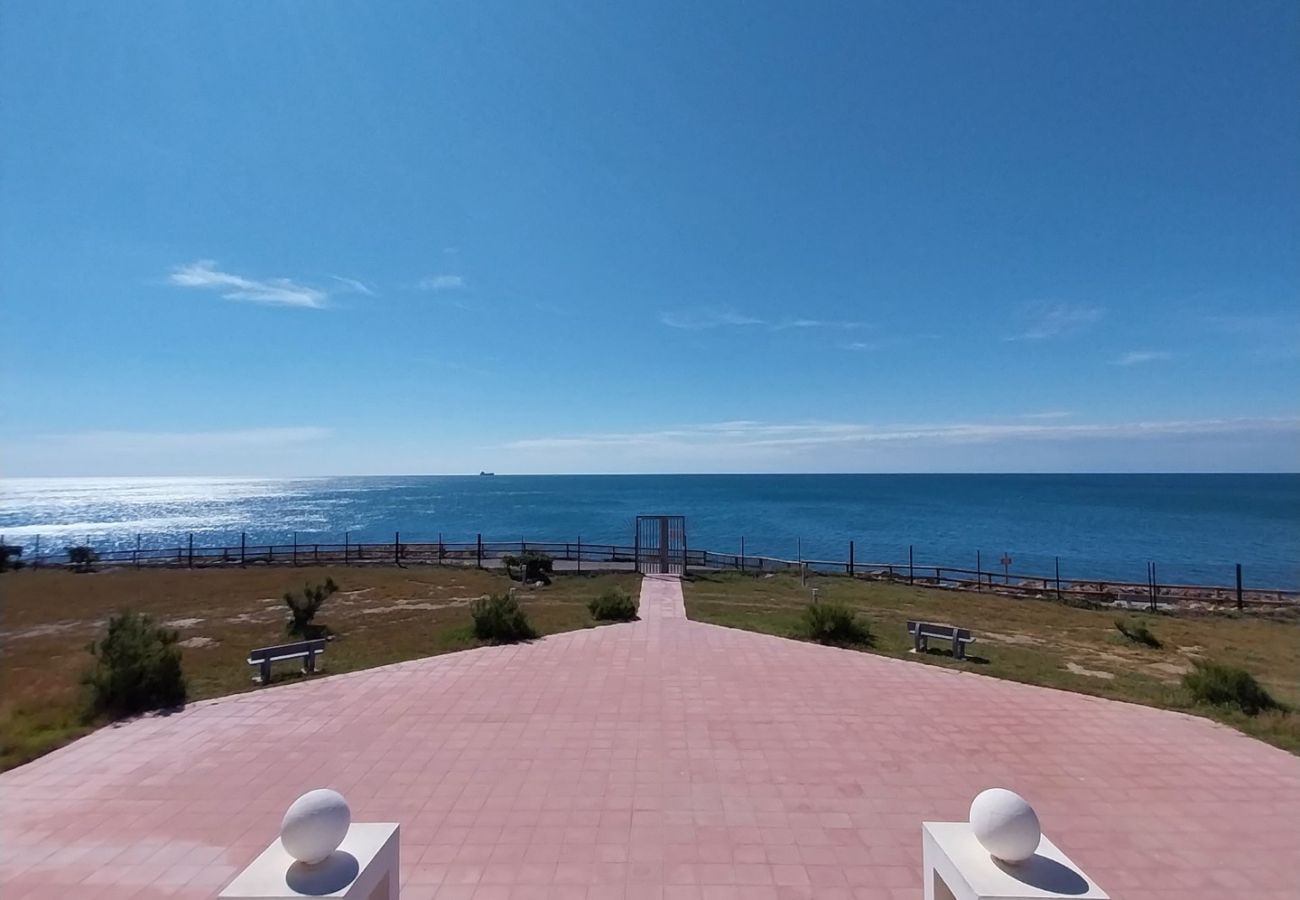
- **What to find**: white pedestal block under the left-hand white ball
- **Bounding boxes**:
[220,822,402,900]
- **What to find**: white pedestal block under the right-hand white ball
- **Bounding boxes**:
[920,822,1109,900]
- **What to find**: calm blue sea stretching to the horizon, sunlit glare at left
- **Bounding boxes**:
[0,475,1300,588]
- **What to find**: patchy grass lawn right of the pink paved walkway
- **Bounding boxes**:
[683,574,1300,753]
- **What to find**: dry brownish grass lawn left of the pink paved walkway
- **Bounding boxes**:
[0,566,640,770]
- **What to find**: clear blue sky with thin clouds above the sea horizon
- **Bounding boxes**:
[0,1,1300,476]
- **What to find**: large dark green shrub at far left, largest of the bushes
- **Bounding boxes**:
[82,613,186,718]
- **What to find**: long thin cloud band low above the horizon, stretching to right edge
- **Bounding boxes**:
[504,414,1300,451]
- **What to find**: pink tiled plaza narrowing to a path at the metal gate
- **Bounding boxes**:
[0,579,1300,900]
